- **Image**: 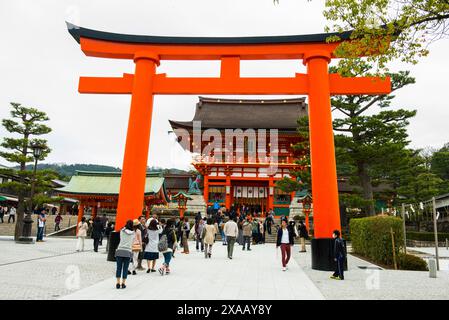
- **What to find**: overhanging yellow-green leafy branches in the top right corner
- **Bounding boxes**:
[324,0,449,72]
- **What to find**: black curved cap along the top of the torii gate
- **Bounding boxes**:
[66,21,352,45]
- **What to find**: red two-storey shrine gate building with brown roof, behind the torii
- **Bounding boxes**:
[170,97,308,216]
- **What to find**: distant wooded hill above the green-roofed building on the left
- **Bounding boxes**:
[16,163,188,180]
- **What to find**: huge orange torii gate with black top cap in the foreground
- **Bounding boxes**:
[67,23,391,269]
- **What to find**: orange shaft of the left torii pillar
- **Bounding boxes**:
[115,52,159,231]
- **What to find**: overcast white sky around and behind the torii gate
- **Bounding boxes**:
[0,0,449,169]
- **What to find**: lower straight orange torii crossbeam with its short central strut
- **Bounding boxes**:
[78,73,391,95]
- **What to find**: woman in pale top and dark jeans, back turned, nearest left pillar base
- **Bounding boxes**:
[115,220,134,289]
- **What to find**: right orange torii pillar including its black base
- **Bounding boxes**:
[304,51,341,270]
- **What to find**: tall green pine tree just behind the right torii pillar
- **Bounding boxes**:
[330,60,416,215]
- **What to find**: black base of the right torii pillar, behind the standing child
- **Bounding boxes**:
[312,238,348,271]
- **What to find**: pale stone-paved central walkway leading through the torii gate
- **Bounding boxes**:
[63,242,323,300]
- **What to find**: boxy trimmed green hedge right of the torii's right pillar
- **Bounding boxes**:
[349,216,404,266]
